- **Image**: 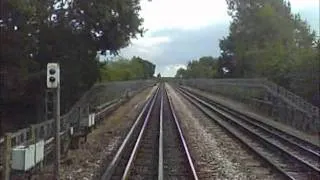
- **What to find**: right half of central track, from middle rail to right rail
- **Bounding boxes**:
[159,85,198,179]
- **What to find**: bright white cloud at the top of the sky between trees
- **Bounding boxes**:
[140,0,230,31]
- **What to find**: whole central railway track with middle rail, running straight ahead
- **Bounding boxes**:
[101,84,198,180]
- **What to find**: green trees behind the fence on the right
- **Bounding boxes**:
[176,0,320,106]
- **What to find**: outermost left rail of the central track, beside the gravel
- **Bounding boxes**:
[101,87,159,180]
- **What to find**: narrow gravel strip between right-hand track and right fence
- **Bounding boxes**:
[181,87,320,146]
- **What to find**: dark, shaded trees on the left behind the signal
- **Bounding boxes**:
[0,0,152,131]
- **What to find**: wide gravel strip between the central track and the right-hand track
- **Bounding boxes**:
[166,84,276,179]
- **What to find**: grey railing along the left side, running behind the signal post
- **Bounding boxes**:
[0,80,155,171]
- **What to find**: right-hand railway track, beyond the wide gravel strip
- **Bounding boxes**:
[178,88,320,179]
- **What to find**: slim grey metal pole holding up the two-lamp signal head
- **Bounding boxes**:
[54,85,60,180]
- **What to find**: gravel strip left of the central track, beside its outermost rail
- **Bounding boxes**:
[61,87,156,180]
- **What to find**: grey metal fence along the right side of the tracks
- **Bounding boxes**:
[175,79,320,133]
